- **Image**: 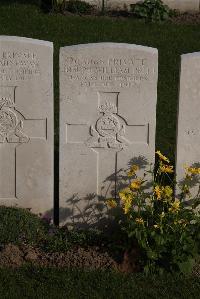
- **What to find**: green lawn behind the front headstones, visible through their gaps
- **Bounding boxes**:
[0,1,200,160]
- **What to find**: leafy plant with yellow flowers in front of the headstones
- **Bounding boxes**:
[107,151,200,274]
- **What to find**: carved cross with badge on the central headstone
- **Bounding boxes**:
[66,92,149,196]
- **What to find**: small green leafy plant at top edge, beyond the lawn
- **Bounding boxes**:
[131,0,171,22]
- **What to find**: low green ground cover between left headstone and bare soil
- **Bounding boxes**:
[0,206,110,254]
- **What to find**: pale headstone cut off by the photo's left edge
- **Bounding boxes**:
[0,36,53,214]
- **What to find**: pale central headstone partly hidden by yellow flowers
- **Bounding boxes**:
[60,43,158,225]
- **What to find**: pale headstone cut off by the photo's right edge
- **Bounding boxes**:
[176,52,200,195]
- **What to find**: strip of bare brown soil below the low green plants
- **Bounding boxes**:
[0,243,117,269]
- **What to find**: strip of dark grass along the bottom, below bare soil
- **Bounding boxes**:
[0,267,200,299]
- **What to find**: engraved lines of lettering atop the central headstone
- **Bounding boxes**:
[63,55,150,89]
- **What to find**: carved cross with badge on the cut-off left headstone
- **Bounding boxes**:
[0,86,47,200]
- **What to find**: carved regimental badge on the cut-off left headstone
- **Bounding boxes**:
[0,96,29,143]
